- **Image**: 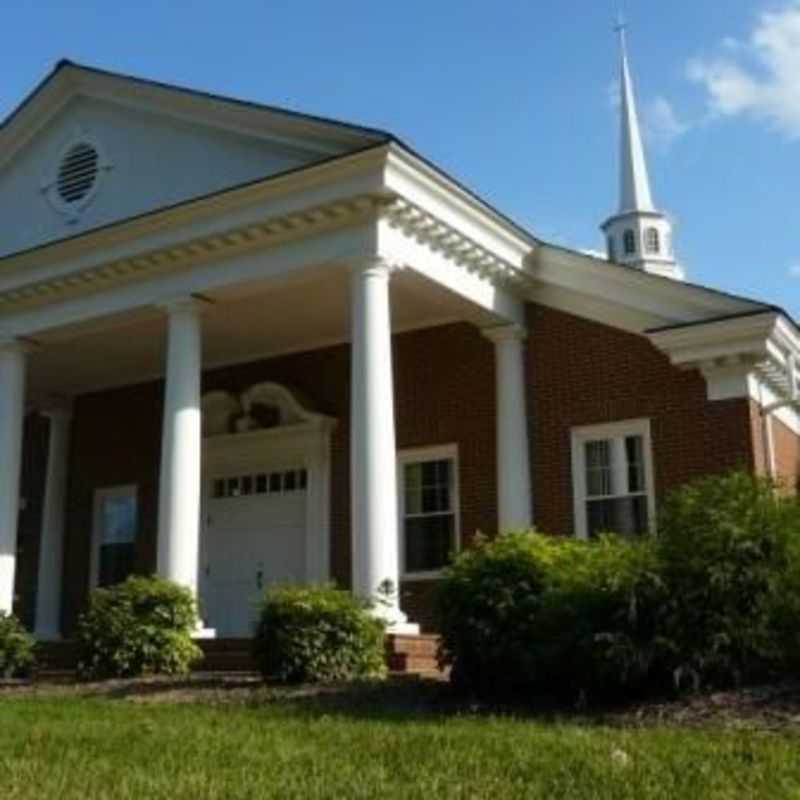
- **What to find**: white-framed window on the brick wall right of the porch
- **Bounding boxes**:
[572,420,655,538]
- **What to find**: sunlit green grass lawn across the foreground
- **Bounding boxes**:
[0,680,800,800]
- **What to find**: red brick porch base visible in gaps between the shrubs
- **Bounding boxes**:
[39,634,441,675]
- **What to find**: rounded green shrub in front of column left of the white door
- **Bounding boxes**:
[78,577,202,678]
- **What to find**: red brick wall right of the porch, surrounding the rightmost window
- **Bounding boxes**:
[527,305,754,534]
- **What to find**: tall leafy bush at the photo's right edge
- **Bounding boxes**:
[657,472,800,687]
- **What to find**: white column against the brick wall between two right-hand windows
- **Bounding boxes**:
[484,325,532,531]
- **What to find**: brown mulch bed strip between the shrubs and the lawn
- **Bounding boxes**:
[9,673,800,731]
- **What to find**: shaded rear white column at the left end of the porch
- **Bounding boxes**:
[36,406,72,640]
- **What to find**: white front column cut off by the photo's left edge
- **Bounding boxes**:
[0,339,25,614]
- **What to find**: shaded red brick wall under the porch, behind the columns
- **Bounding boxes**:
[51,323,497,630]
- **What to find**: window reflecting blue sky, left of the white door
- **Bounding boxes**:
[92,486,139,586]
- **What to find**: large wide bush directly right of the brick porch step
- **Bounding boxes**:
[437,533,661,699]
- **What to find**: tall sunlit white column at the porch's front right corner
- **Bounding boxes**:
[350,259,418,631]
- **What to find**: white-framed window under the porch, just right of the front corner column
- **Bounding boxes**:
[398,446,459,577]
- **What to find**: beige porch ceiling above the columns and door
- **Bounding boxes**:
[28,262,493,406]
